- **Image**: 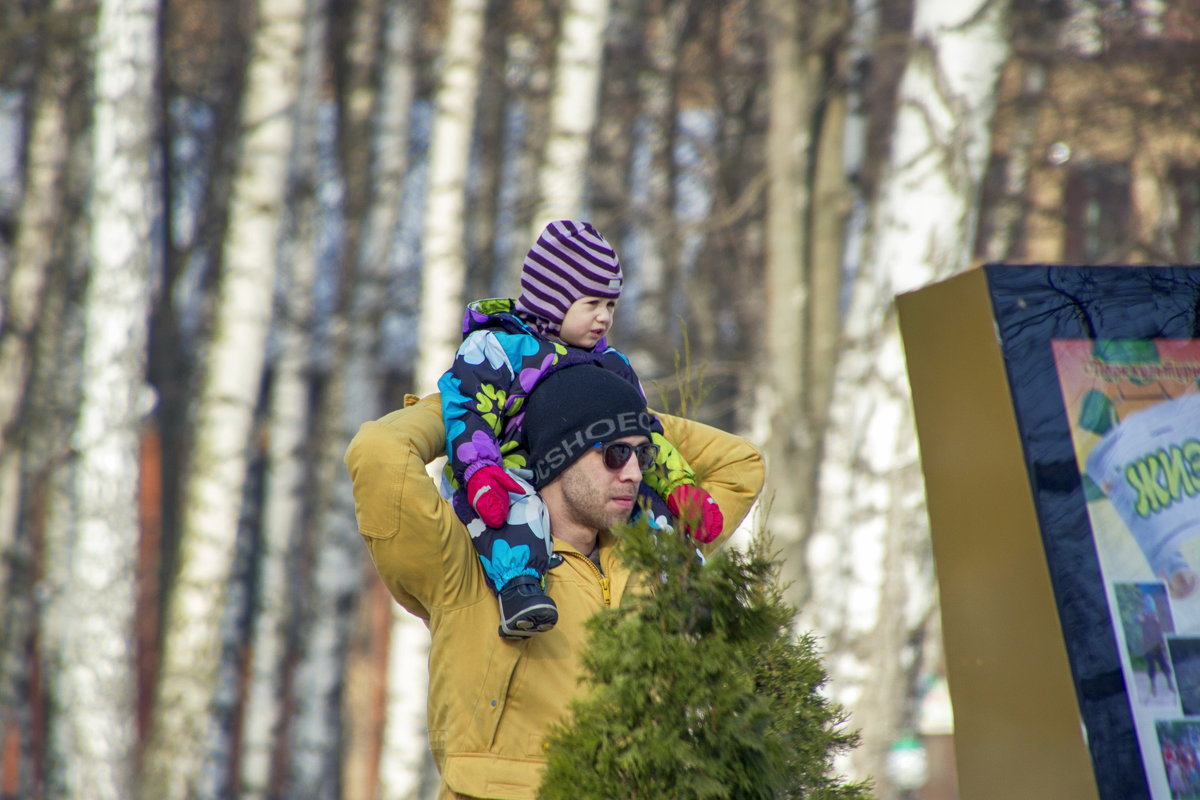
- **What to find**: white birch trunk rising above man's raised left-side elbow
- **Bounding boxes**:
[414,0,485,395]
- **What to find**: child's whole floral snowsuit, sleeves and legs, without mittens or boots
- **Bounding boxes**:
[438,297,696,591]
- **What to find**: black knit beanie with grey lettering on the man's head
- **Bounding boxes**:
[523,363,654,488]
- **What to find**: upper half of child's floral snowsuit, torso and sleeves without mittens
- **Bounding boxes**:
[438,297,696,516]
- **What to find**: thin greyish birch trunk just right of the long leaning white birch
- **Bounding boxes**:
[239,0,328,800]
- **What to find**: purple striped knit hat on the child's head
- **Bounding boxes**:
[516,219,622,333]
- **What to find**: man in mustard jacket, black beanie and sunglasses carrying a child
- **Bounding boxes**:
[346,365,763,800]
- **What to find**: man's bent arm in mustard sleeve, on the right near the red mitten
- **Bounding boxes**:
[658,414,764,553]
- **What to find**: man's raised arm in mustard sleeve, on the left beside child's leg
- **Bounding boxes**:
[346,395,481,620]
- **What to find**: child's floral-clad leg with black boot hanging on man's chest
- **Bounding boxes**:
[460,473,558,638]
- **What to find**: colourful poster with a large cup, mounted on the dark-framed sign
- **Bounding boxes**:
[1051,339,1200,798]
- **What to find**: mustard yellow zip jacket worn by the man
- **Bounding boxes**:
[346,395,763,800]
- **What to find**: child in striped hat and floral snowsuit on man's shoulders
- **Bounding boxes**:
[438,221,724,638]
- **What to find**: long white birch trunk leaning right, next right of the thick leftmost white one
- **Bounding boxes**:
[142,0,305,800]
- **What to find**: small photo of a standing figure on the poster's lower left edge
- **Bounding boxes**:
[1112,582,1178,710]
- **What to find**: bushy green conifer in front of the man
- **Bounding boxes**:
[538,515,868,800]
